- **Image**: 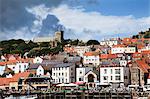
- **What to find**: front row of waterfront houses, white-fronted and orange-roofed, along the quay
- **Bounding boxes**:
[0,55,150,90]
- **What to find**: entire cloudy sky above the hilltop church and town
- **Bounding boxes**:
[0,0,150,41]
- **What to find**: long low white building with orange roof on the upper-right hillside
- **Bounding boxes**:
[111,46,136,54]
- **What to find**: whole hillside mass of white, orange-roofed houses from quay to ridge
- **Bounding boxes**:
[0,38,150,90]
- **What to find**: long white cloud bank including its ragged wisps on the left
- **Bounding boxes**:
[26,5,150,40]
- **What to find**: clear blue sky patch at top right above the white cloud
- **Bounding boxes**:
[64,0,150,18]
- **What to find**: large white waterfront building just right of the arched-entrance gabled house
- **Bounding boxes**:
[100,66,129,86]
